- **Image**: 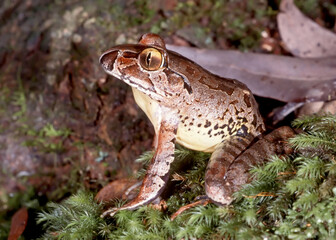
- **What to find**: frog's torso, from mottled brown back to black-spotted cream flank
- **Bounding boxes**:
[170,54,265,152]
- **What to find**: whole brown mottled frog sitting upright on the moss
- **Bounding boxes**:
[100,34,294,216]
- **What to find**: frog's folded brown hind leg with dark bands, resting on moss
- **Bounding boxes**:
[205,127,295,205]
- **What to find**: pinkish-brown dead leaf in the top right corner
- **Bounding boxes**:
[277,0,336,58]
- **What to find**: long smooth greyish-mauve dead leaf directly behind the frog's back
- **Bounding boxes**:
[167,45,336,102]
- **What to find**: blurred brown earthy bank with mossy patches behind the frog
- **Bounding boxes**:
[0,0,336,238]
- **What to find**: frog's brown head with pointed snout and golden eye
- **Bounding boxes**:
[100,33,192,101]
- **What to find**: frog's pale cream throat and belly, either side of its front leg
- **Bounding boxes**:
[132,87,224,152]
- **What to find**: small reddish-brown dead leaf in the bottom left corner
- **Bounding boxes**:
[8,208,28,240]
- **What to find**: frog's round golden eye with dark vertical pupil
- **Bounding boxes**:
[139,48,164,71]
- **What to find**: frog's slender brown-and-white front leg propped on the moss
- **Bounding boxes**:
[102,107,178,217]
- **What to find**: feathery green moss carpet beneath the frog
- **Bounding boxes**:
[39,115,336,239]
